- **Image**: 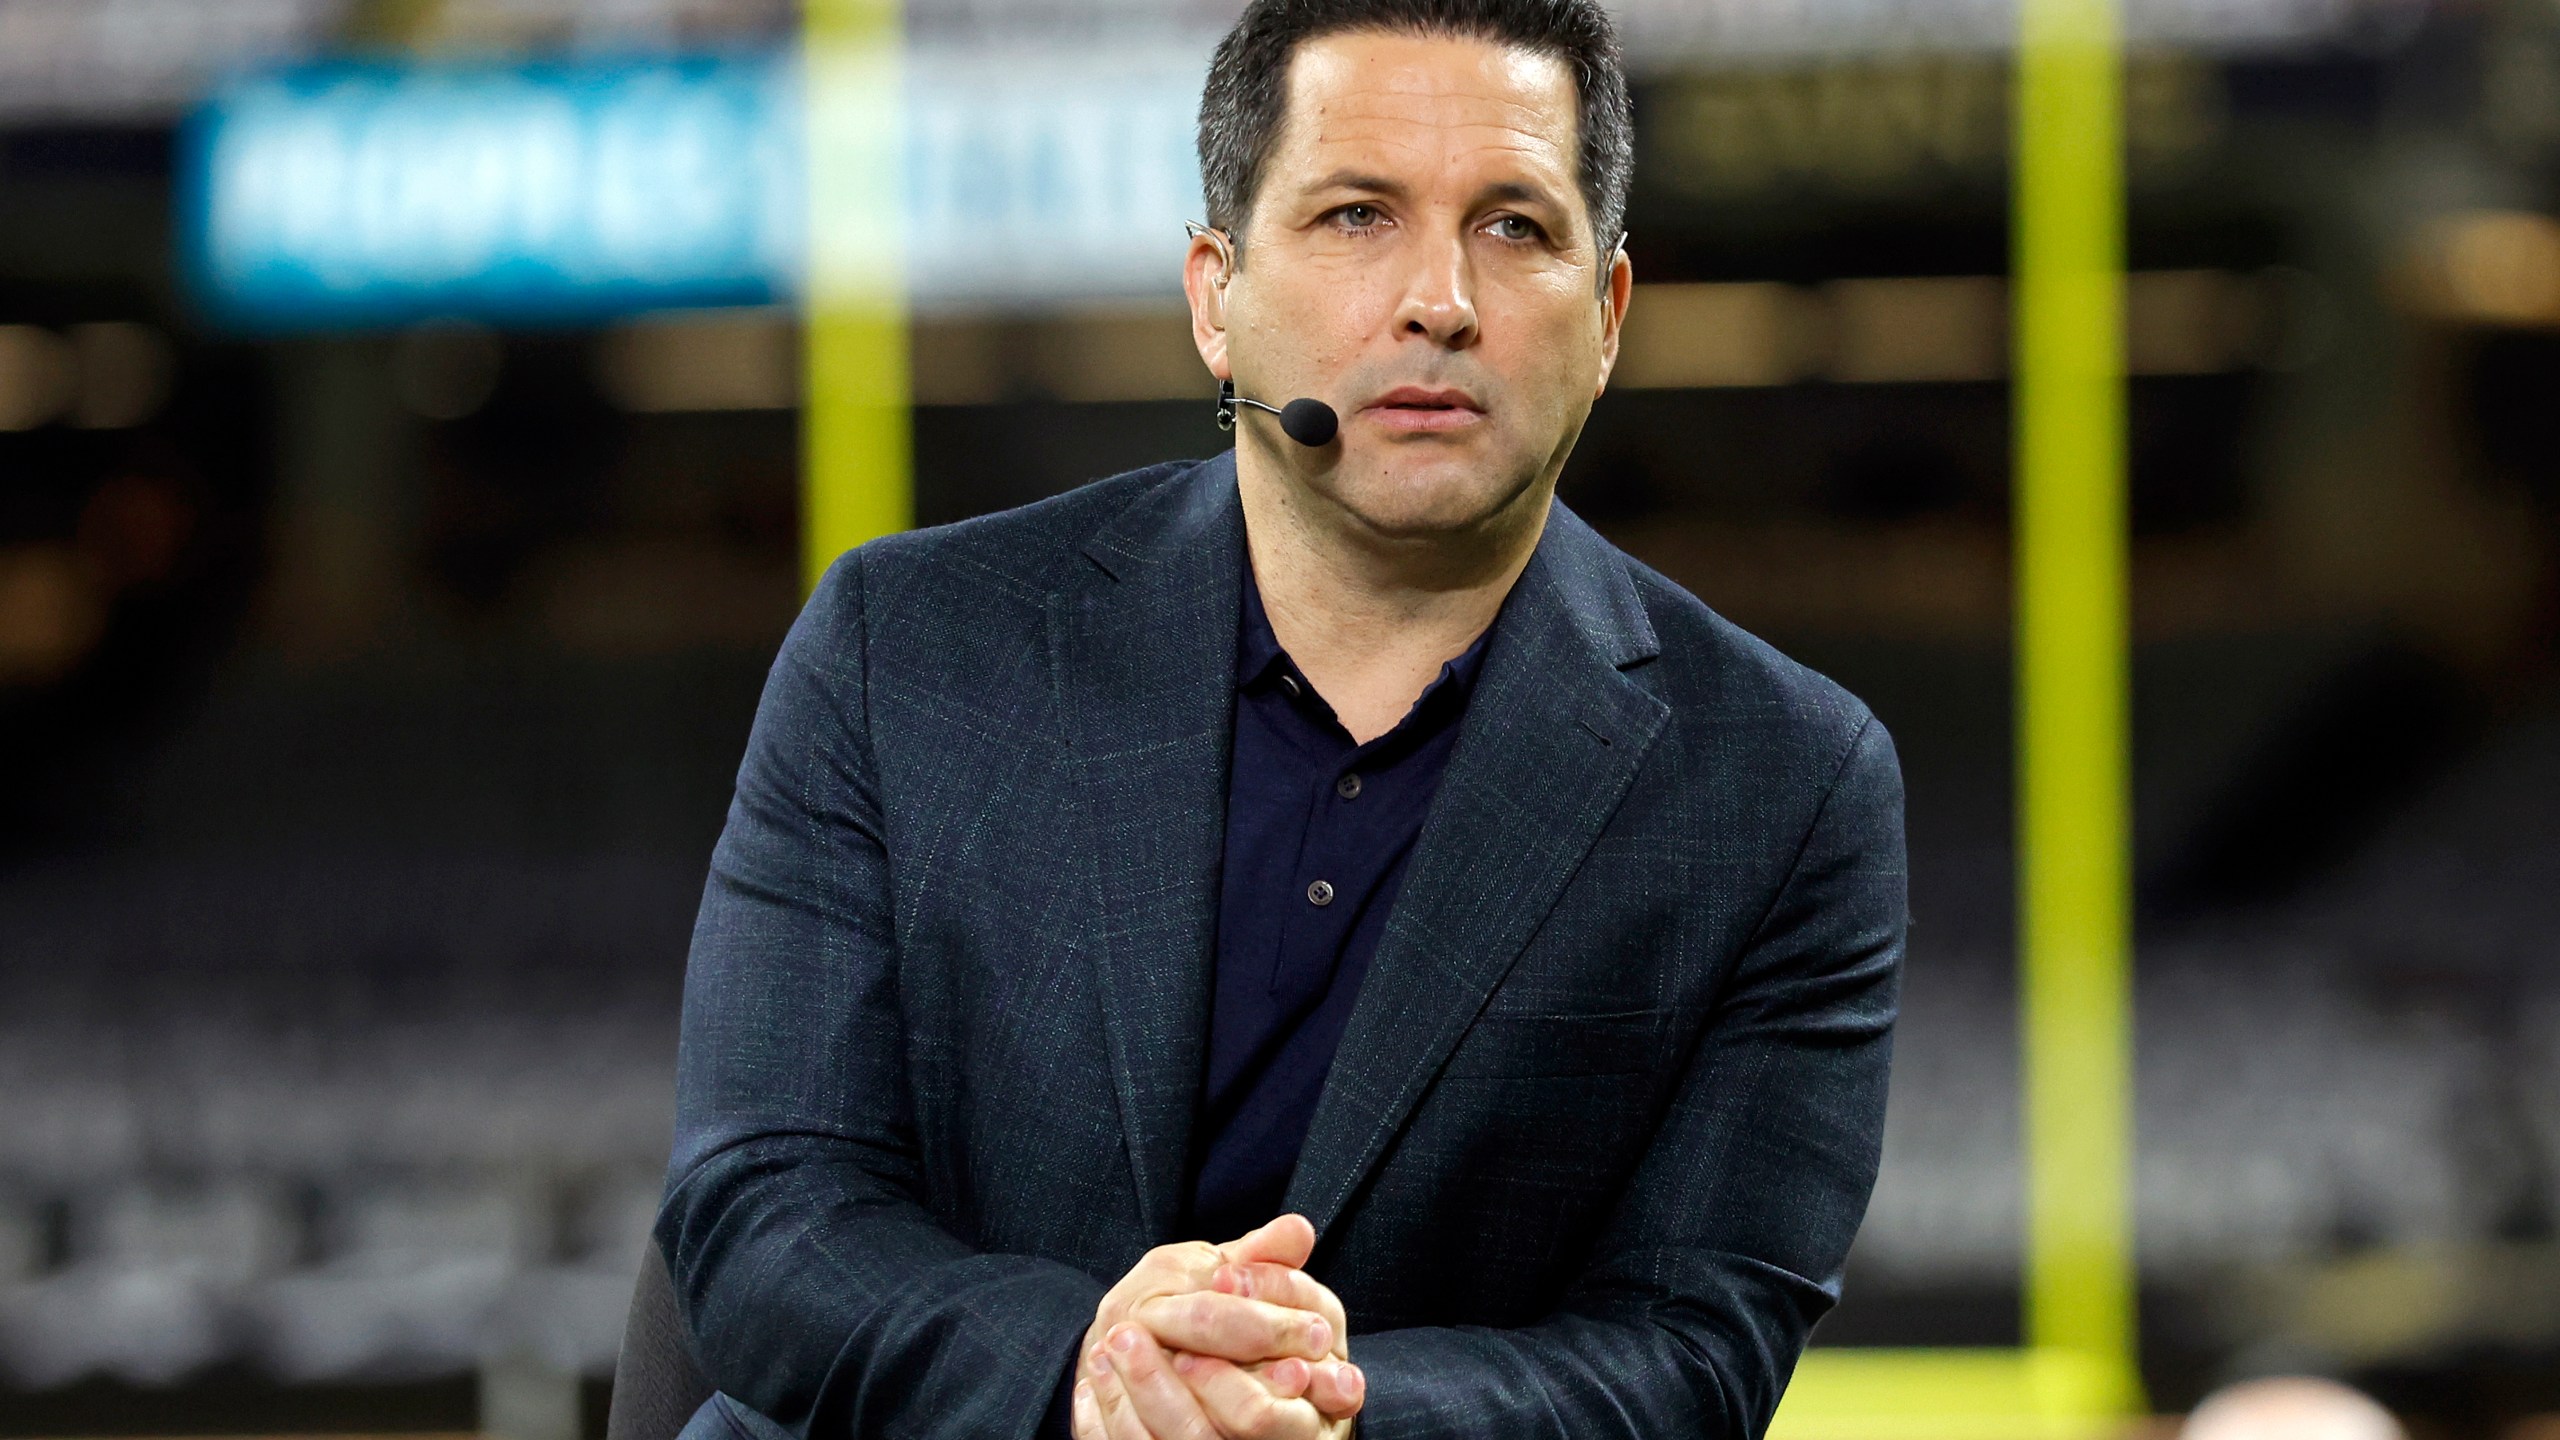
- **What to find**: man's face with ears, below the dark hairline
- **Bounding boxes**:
[1185,31,1631,538]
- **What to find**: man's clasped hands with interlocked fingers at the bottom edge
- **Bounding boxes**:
[1075,1215,1367,1440]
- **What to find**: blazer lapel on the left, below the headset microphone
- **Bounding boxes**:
[1050,454,1244,1243]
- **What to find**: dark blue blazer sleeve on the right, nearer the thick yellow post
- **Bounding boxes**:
[1352,717,1907,1440]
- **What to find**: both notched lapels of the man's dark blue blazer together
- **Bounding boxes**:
[1050,451,1669,1243]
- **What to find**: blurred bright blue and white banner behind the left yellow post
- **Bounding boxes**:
[179,54,1201,331]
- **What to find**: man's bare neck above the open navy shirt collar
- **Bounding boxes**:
[1236,446,1554,743]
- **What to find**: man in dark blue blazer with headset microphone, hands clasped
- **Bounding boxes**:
[658,0,1905,1440]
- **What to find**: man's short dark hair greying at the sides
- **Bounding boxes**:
[1201,0,1636,263]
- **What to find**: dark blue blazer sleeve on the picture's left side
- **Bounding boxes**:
[655,551,1103,1440]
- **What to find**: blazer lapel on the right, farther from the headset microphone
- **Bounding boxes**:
[1288,505,1669,1232]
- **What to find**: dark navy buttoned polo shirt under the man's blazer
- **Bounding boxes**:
[1185,564,1492,1240]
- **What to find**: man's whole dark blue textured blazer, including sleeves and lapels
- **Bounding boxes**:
[658,454,1905,1440]
